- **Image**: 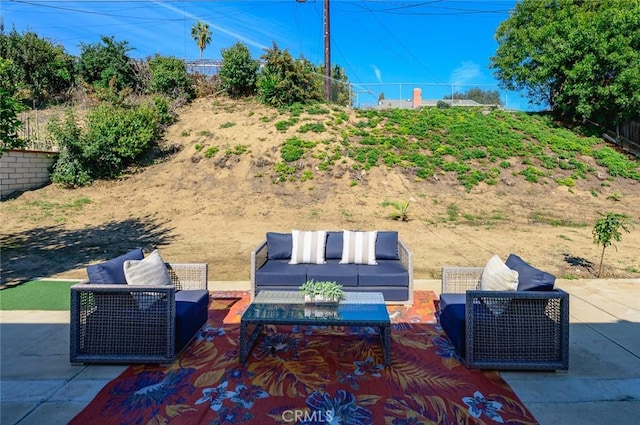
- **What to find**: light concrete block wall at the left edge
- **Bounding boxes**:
[0,150,57,199]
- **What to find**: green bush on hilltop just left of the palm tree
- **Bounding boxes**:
[148,55,195,100]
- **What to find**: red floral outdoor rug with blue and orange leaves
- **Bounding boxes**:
[70,292,537,425]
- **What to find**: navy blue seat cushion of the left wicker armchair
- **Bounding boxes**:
[175,289,209,353]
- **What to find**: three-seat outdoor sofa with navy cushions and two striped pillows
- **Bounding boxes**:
[251,230,413,304]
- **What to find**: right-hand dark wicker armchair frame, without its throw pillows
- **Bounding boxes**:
[440,267,569,370]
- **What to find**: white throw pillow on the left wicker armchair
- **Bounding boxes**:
[123,249,173,310]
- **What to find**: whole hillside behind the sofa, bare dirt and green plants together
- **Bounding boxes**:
[0,98,640,282]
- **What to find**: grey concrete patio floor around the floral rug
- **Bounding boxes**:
[0,279,640,425]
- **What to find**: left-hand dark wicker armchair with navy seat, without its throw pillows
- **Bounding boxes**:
[70,263,209,364]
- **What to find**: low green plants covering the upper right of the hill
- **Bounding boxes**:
[275,103,640,190]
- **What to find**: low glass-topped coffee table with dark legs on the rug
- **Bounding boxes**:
[240,291,391,366]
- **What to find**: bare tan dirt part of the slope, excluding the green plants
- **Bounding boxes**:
[0,98,640,282]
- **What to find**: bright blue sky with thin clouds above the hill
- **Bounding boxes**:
[0,0,530,109]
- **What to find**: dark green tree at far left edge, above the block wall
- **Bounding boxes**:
[0,57,25,156]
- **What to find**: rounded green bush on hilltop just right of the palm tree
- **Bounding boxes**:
[218,42,260,97]
